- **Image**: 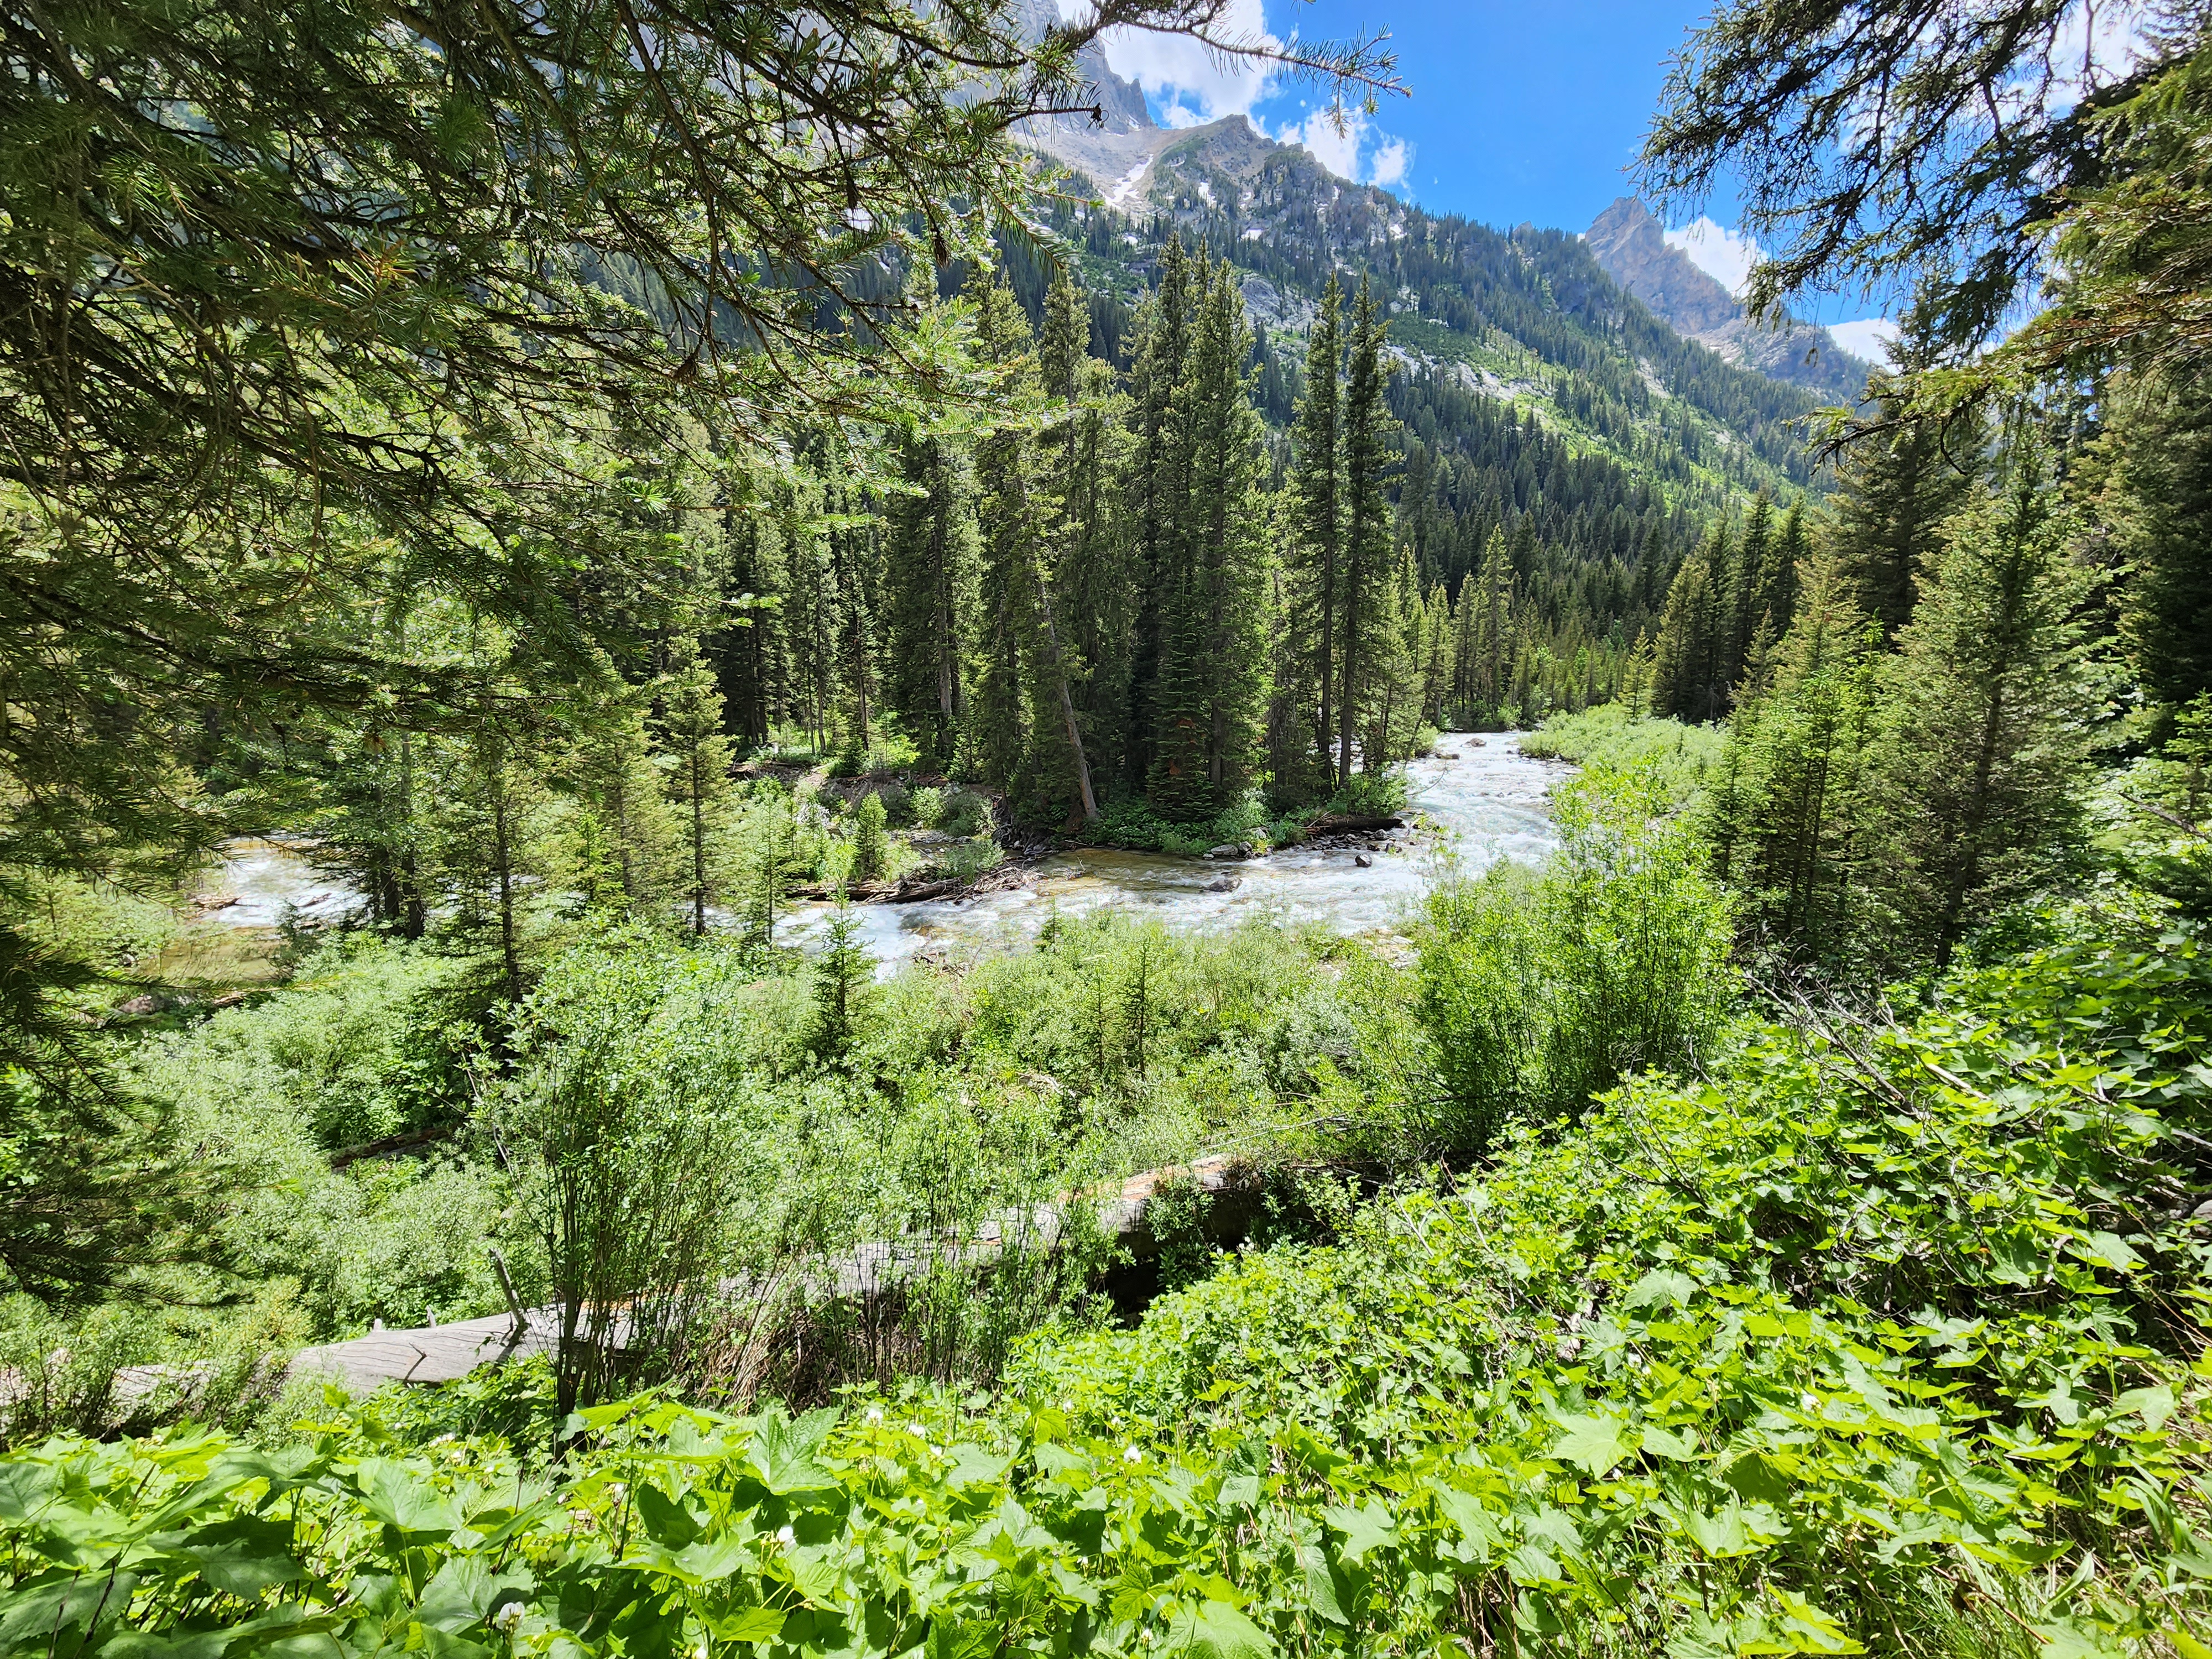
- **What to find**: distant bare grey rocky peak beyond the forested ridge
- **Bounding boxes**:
[1584,197,1871,400]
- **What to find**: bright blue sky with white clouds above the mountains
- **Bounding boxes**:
[1088,0,1902,349]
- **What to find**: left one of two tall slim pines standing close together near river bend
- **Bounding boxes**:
[1285,272,1345,787]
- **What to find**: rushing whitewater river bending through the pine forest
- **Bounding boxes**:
[206,732,1566,973]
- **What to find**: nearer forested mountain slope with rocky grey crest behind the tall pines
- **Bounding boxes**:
[1018,68,1856,511]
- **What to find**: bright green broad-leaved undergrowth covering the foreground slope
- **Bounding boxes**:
[0,909,2212,1659]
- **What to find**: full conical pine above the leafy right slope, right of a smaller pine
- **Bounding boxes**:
[1882,440,2088,969]
